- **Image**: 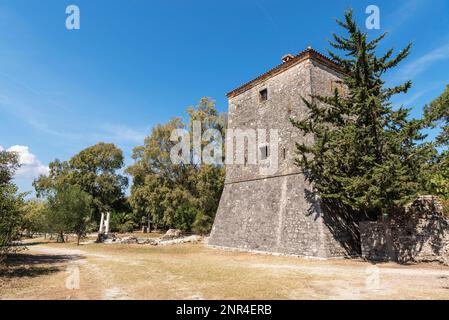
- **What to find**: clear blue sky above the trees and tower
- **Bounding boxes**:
[0,0,449,191]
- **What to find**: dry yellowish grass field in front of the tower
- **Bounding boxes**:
[0,239,449,299]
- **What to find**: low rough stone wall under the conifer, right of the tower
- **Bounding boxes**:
[360,196,449,264]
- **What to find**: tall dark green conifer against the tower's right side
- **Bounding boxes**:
[292,11,429,214]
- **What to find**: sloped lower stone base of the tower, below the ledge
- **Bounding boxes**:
[209,174,357,258]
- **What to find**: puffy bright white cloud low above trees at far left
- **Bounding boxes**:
[4,145,49,178]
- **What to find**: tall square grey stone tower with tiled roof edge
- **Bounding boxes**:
[209,48,357,258]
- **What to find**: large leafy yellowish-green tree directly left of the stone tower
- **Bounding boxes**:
[126,98,226,231]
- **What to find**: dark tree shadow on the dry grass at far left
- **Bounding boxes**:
[0,253,82,279]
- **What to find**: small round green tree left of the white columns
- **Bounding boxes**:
[47,185,92,245]
